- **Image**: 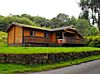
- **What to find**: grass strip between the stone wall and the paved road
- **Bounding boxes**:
[0,55,100,74]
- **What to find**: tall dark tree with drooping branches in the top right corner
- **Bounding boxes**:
[79,0,100,32]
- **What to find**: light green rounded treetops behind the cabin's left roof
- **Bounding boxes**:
[0,16,37,31]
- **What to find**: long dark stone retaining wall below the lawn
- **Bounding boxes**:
[0,51,100,65]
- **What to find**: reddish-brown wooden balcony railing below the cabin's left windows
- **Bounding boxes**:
[24,36,50,43]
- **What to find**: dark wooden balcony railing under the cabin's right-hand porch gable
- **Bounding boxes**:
[64,37,85,44]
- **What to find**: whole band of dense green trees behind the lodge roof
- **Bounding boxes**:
[0,13,98,36]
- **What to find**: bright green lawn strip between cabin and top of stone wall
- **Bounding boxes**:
[0,47,100,54]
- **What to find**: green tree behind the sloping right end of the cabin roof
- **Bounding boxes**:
[69,16,98,36]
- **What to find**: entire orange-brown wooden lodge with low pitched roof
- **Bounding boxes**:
[7,23,84,46]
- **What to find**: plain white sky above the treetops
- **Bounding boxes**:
[0,0,81,19]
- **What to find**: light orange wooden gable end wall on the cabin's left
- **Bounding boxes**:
[8,25,23,46]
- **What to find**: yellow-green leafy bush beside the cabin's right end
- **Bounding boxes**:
[86,36,100,47]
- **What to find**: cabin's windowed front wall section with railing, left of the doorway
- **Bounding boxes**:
[23,28,50,44]
